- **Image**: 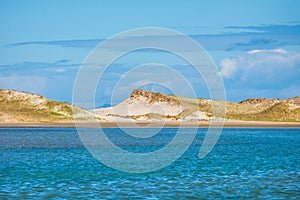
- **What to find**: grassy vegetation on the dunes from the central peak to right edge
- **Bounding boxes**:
[127,90,300,122]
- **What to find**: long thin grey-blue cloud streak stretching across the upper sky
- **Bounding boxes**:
[9,24,300,51]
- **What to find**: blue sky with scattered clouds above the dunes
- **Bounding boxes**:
[0,0,300,106]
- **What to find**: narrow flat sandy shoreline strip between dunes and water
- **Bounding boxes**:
[0,121,300,128]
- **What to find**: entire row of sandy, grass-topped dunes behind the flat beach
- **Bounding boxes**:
[0,89,300,123]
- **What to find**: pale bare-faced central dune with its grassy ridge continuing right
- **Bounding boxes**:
[92,90,300,122]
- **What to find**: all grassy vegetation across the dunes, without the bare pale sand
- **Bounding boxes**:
[0,89,300,122]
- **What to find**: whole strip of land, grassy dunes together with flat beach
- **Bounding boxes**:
[0,90,300,127]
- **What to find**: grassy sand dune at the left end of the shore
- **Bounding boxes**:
[0,90,82,122]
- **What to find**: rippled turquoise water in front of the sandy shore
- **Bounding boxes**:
[0,128,300,199]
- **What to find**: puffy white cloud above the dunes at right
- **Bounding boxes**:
[220,49,300,90]
